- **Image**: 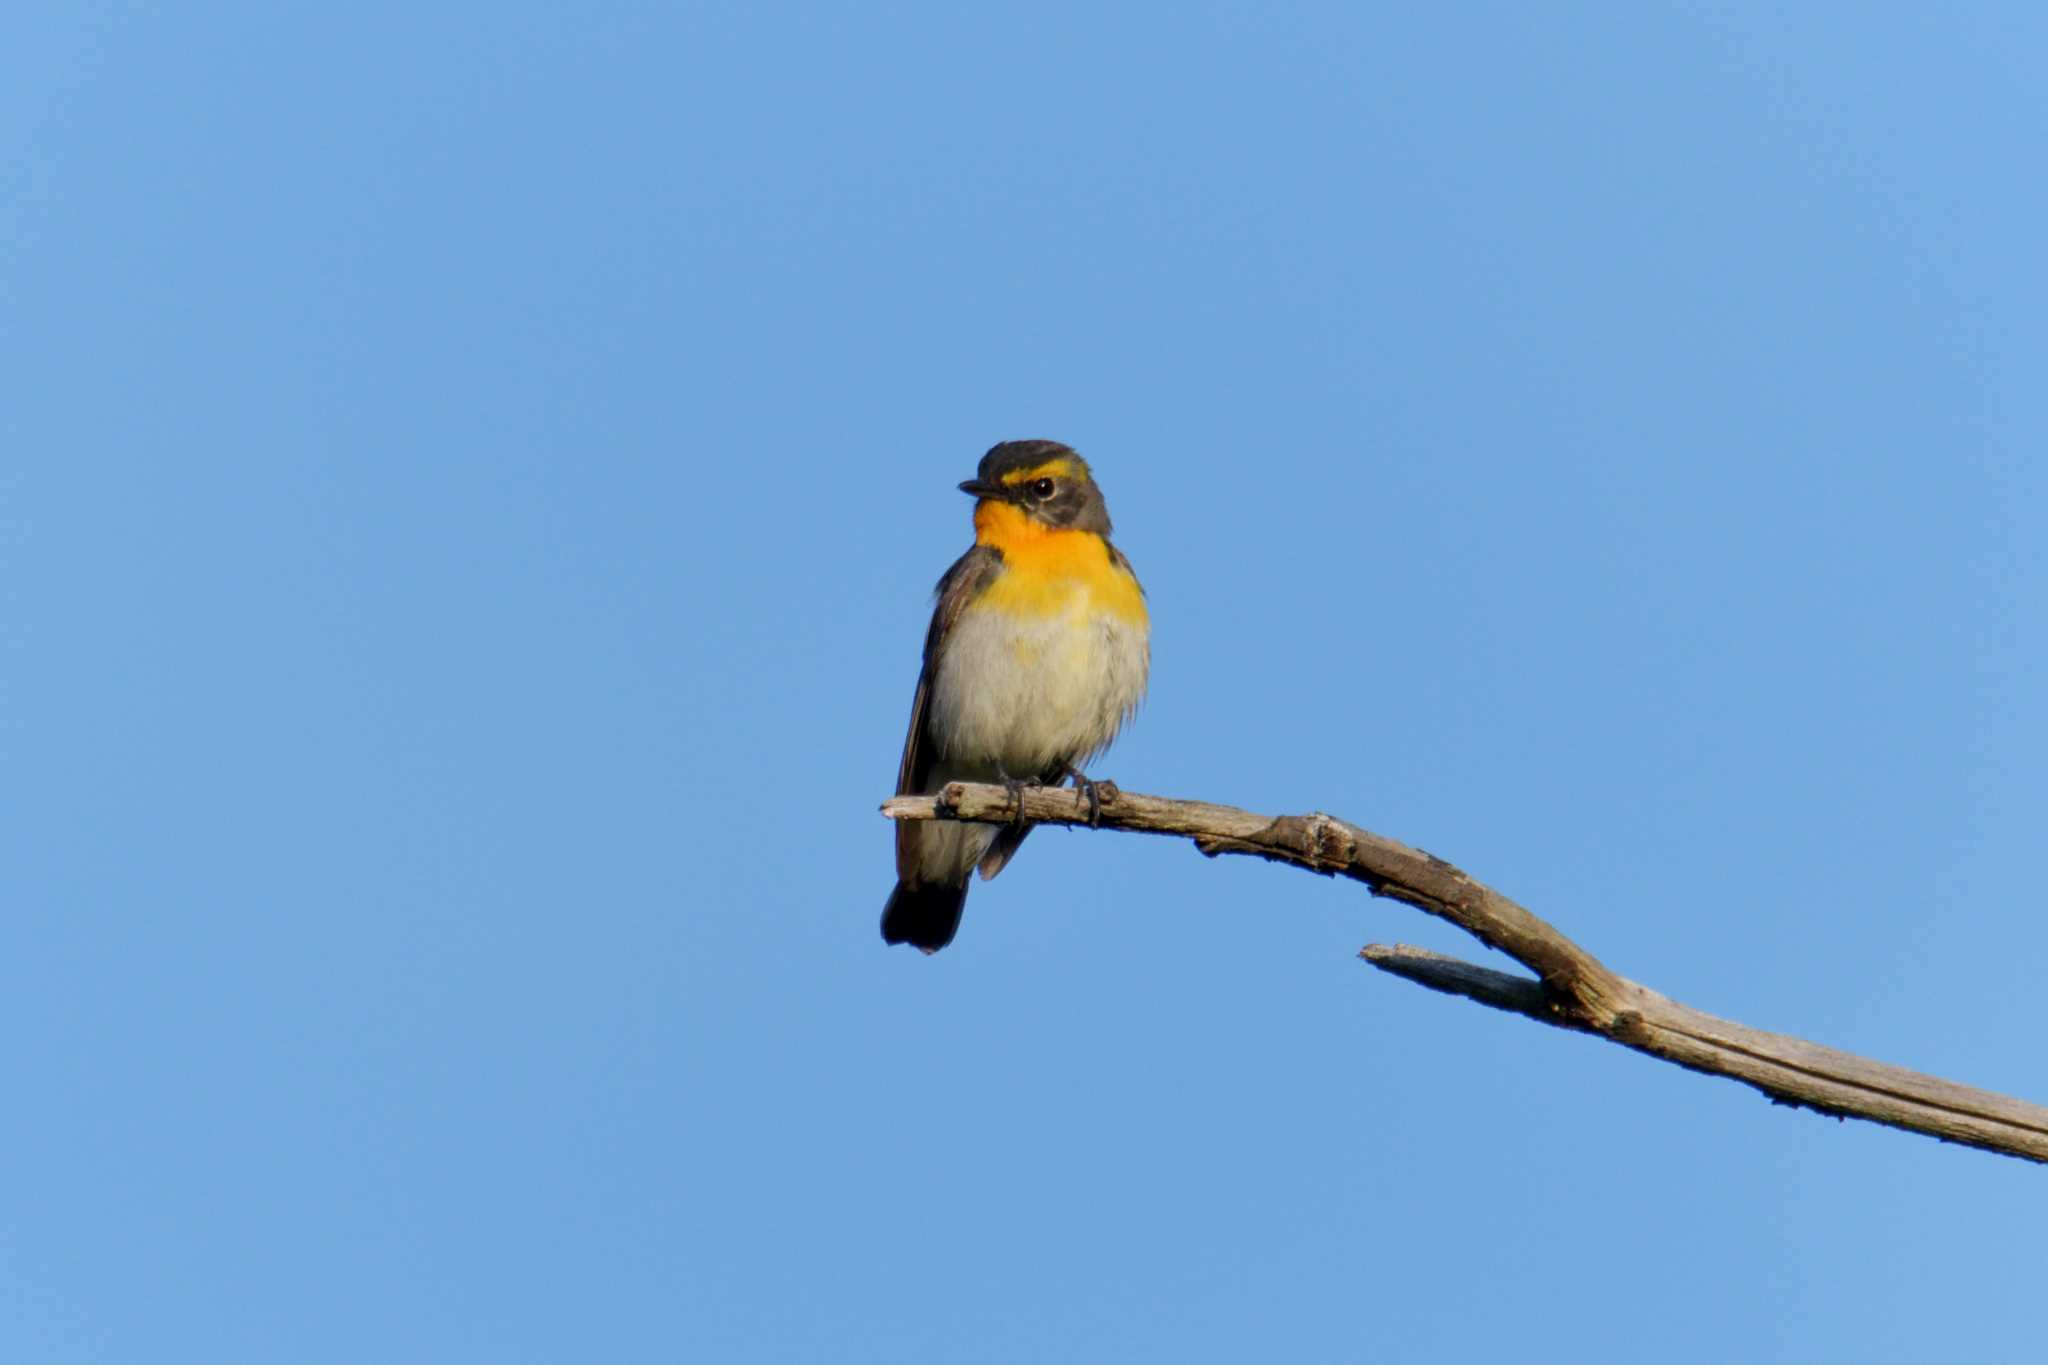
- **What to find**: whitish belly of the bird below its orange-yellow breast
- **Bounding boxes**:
[930,589,1151,780]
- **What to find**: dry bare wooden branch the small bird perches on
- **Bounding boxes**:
[883,782,2048,1162]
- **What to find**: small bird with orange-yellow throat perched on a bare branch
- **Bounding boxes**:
[883,440,1151,954]
